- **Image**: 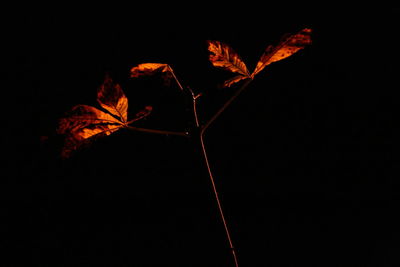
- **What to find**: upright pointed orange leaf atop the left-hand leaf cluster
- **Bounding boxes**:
[97,75,128,122]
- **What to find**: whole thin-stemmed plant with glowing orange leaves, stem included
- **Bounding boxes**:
[58,28,311,267]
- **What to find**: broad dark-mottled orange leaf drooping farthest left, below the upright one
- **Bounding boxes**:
[57,105,123,158]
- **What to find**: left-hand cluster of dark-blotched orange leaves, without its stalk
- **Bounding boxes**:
[57,76,151,158]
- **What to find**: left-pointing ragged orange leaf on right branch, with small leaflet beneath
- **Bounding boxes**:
[208,41,250,87]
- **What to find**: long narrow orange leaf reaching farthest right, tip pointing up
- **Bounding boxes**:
[251,28,311,78]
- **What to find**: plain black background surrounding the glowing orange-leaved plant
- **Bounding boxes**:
[4,3,400,266]
